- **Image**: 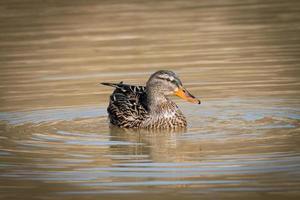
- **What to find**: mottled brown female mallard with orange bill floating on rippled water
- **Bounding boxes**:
[102,70,200,128]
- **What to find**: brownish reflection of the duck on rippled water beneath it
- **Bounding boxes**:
[110,127,200,162]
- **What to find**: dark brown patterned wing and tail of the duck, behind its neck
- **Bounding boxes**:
[101,82,148,128]
